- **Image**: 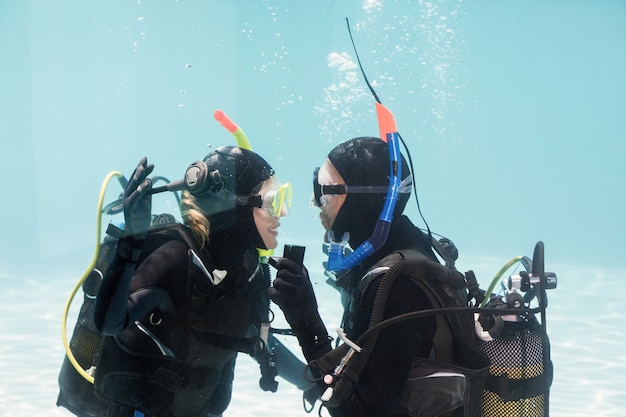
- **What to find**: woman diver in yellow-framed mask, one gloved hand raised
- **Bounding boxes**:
[94,146,291,417]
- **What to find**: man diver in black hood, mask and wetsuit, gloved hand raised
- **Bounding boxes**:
[268,137,448,417]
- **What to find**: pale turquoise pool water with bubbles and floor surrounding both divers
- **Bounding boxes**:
[0,0,626,417]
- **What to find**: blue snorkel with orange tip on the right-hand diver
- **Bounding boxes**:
[326,102,402,272]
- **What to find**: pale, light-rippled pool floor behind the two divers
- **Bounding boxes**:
[0,255,626,417]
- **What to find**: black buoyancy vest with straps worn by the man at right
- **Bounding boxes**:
[311,250,489,416]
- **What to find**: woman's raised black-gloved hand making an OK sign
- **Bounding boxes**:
[122,157,154,240]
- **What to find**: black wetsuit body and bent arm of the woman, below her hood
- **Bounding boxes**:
[95,228,264,417]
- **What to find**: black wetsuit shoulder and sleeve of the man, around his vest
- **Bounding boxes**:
[314,216,437,417]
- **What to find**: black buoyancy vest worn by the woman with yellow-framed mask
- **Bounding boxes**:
[57,224,259,417]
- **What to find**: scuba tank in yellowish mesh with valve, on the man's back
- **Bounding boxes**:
[475,242,557,417]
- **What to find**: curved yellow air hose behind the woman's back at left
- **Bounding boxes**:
[61,171,122,384]
